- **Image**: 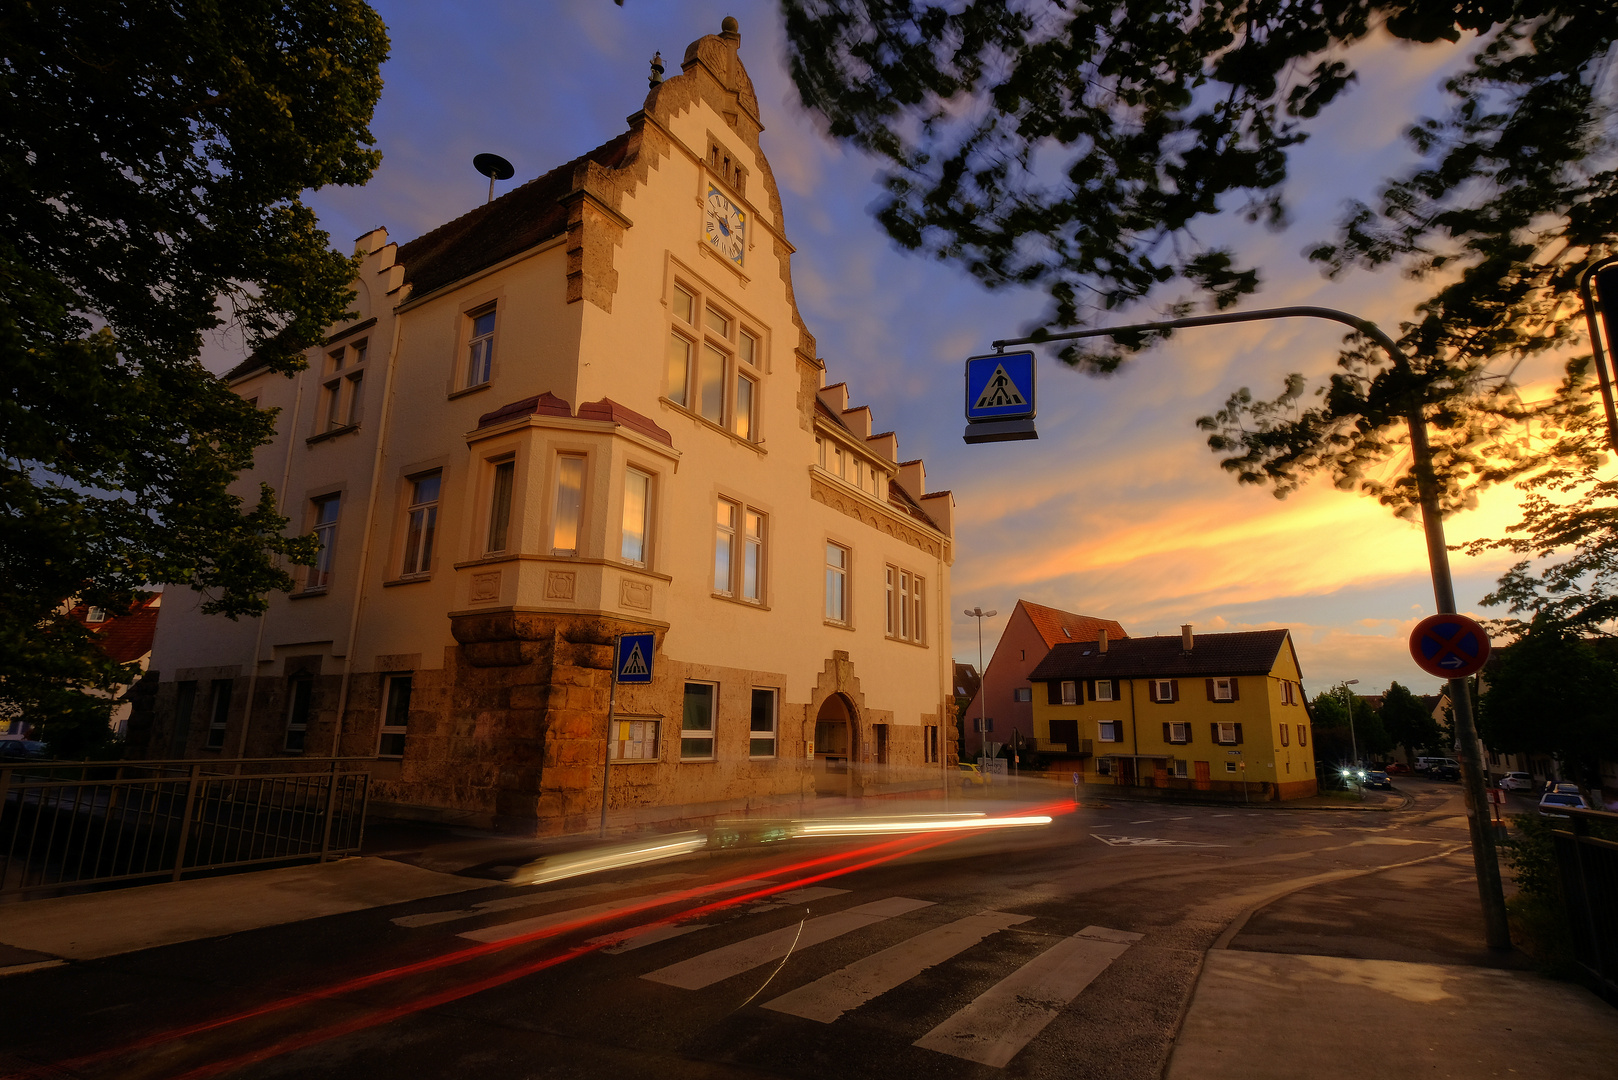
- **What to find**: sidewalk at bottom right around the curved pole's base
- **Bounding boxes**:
[1165,852,1618,1080]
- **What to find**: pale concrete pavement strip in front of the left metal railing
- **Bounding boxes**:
[0,858,478,973]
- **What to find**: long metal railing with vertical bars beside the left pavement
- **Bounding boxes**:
[0,758,372,895]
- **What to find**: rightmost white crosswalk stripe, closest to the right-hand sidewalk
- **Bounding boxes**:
[913,926,1141,1069]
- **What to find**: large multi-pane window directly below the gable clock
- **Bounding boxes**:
[667,282,764,442]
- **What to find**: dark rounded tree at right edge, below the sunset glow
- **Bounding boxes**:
[1477,622,1618,787]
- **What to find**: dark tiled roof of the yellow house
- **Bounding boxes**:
[1027,630,1288,682]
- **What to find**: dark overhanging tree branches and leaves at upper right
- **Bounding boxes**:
[783,0,1618,513]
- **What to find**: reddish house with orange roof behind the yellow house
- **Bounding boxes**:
[964,601,1129,753]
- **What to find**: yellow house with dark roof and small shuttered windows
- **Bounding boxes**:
[1029,625,1317,800]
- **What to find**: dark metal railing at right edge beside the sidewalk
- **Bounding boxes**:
[1550,810,1618,994]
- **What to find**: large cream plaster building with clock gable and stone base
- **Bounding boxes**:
[147,21,955,832]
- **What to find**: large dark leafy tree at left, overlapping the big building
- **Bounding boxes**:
[0,0,387,738]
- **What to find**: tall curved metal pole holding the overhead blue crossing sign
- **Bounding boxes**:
[993,306,1511,949]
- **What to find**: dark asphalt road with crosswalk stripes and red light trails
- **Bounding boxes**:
[0,780,1526,1080]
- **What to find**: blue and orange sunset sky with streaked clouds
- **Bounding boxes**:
[239,0,1592,693]
